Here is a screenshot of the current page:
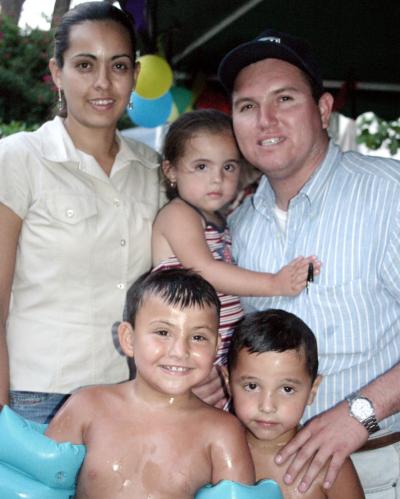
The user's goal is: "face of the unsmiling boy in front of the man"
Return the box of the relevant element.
[231,349,319,441]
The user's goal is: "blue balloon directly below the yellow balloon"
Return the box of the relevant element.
[127,91,173,128]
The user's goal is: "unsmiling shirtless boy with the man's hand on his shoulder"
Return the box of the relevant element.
[228,309,364,499]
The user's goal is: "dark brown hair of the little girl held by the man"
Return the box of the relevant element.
[163,109,239,199]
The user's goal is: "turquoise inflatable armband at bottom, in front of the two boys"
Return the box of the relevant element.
[194,480,283,499]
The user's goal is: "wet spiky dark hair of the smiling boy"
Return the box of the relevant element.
[123,269,221,328]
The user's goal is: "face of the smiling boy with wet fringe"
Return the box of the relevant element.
[125,295,218,396]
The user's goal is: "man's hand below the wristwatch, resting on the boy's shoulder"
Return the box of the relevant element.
[275,402,368,492]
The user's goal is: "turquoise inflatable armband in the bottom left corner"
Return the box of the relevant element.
[0,406,86,499]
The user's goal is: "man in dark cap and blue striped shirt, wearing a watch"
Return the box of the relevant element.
[219,30,400,499]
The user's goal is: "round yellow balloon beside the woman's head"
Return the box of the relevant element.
[135,54,173,99]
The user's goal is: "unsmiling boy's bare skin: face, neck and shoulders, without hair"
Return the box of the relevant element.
[231,349,363,499]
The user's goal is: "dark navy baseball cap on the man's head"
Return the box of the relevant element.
[218,29,323,94]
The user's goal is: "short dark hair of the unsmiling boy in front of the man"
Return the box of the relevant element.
[228,308,318,382]
